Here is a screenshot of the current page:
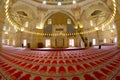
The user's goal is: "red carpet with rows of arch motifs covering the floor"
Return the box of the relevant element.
[0,46,120,80]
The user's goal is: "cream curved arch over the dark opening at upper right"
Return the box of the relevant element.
[81,1,111,20]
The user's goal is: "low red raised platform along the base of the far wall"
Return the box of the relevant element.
[31,47,85,51]
